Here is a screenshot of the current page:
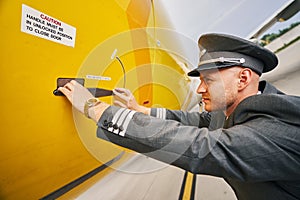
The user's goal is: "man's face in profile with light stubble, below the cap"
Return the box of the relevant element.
[197,68,238,112]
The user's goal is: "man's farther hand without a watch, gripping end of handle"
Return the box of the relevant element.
[113,88,150,115]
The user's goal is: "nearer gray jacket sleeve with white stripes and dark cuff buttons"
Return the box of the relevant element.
[97,106,300,181]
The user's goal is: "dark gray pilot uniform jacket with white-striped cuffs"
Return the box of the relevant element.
[97,82,300,200]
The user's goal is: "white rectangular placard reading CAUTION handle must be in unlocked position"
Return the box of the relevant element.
[21,4,76,47]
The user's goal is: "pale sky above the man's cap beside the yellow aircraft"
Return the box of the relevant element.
[160,0,300,40]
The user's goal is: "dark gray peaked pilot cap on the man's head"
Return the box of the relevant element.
[188,33,278,76]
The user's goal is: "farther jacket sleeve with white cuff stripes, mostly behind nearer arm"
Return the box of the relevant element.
[150,108,211,127]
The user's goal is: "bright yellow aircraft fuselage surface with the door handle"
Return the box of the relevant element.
[0,0,190,199]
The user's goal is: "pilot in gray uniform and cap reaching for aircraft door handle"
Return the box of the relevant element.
[59,33,300,200]
